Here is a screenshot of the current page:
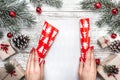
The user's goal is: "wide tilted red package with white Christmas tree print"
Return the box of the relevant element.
[37,21,59,61]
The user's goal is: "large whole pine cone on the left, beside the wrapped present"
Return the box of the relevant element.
[12,35,30,50]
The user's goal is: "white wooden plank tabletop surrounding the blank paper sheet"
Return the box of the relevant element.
[0,0,120,80]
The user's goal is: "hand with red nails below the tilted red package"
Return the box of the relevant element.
[26,48,45,80]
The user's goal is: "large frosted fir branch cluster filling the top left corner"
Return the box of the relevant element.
[0,0,35,33]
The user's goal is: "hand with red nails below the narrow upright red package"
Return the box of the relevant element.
[79,46,97,80]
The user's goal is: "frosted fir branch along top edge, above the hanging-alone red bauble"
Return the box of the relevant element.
[30,0,63,8]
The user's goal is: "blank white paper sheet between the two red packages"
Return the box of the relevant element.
[45,19,80,80]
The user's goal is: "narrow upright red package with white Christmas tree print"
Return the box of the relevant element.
[80,18,90,60]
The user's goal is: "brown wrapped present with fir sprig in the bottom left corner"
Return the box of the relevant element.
[0,59,25,80]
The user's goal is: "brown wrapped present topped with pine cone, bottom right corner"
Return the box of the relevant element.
[97,54,120,80]
